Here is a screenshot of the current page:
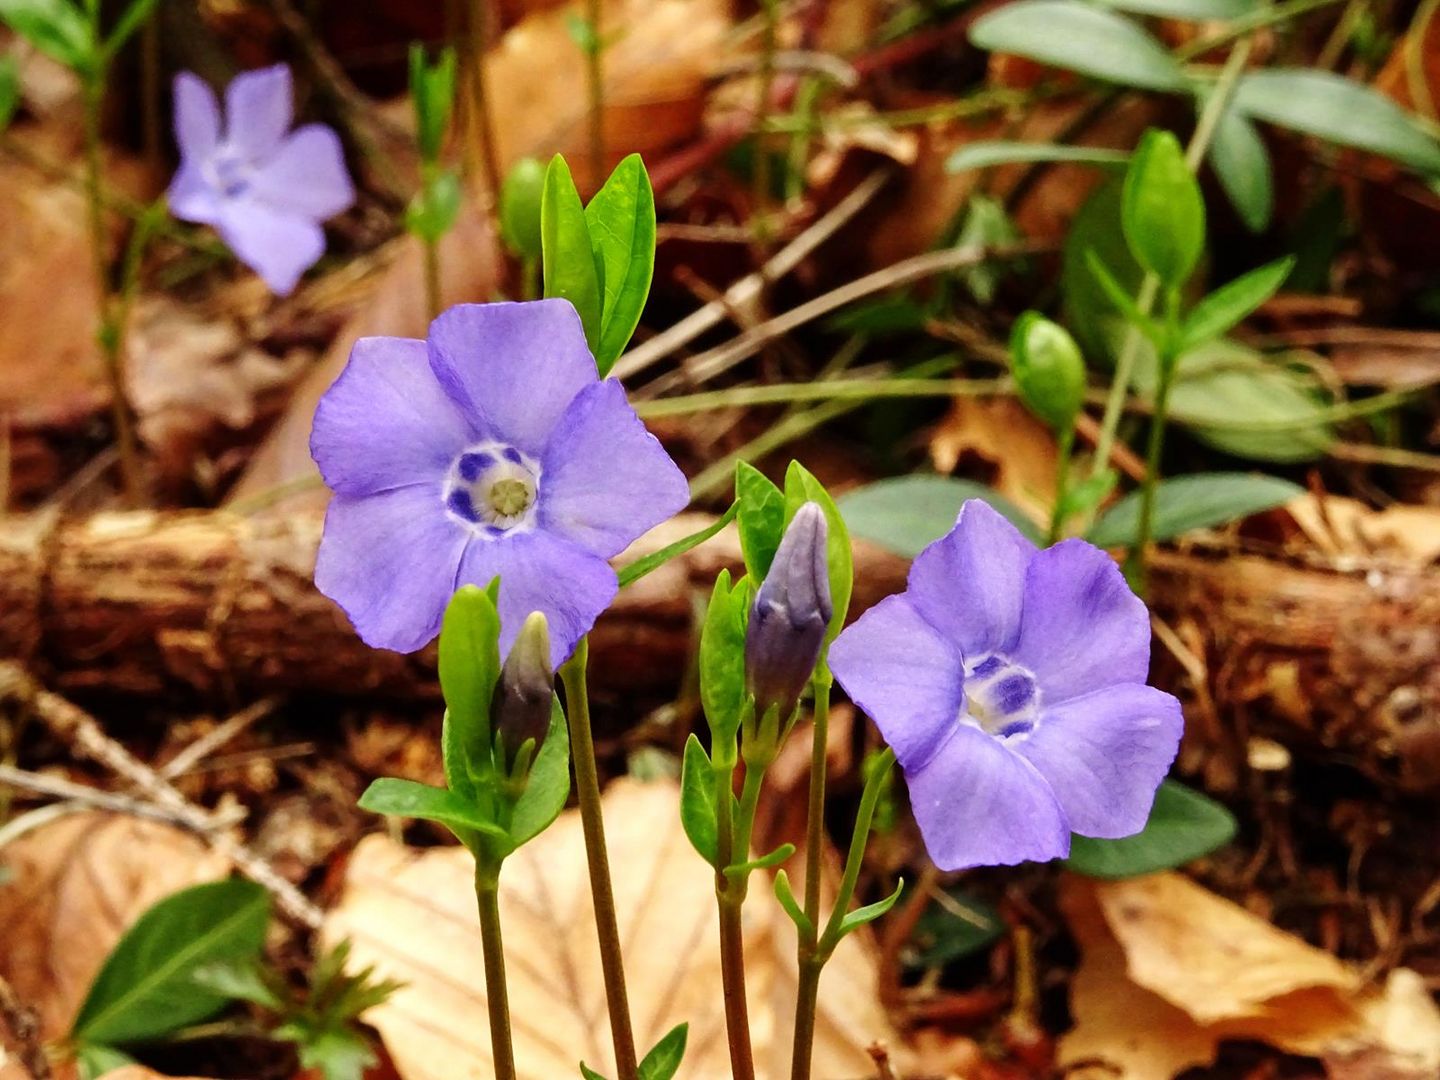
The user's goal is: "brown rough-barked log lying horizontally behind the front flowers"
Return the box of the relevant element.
[0,508,1440,791]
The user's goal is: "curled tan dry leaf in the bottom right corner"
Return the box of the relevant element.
[1060,874,1440,1080]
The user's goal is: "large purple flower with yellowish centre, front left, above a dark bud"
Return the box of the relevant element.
[310,300,690,667]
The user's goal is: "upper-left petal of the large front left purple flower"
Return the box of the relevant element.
[310,337,474,504]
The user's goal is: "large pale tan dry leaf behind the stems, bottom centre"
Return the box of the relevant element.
[323,780,894,1080]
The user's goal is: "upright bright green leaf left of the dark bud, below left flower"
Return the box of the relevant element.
[434,585,504,800]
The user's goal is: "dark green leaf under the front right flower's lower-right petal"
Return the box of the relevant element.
[1066,780,1236,878]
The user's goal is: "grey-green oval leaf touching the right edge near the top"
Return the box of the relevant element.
[1234,68,1440,176]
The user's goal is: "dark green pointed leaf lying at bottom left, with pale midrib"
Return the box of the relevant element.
[71,880,271,1044]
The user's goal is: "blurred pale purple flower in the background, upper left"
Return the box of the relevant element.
[168,63,354,297]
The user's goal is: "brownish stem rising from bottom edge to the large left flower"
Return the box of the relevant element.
[560,638,636,1080]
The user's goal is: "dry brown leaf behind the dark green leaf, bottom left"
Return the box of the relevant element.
[0,814,230,1042]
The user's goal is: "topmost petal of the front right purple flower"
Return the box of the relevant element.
[907,498,1035,657]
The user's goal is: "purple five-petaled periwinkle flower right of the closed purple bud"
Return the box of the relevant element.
[829,500,1184,870]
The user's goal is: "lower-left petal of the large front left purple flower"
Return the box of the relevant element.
[315,484,469,652]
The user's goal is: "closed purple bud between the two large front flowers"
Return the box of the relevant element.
[744,503,832,716]
